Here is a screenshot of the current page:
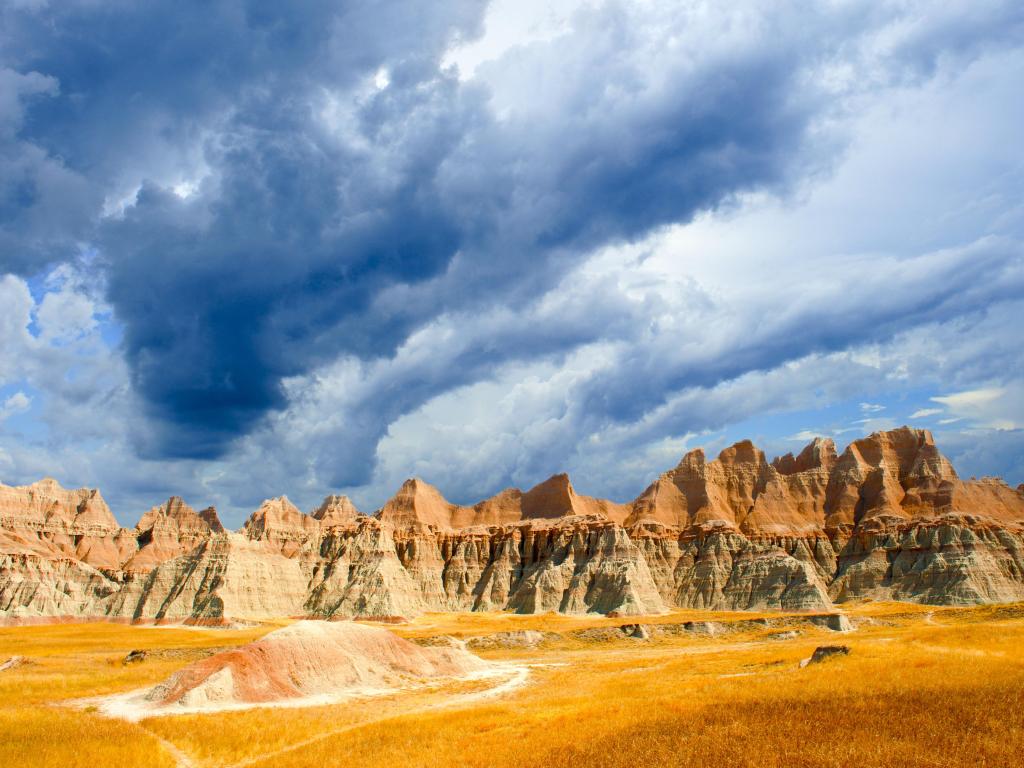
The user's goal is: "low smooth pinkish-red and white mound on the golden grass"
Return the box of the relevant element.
[98,621,497,720]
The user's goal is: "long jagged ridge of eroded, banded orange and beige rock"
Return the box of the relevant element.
[0,427,1024,626]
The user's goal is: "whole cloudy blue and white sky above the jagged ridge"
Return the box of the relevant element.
[0,0,1024,526]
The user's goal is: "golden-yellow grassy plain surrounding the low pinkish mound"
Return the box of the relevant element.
[0,603,1024,768]
